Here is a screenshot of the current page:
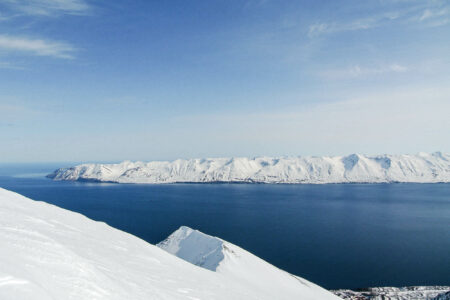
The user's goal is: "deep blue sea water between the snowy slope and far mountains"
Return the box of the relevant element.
[0,164,450,289]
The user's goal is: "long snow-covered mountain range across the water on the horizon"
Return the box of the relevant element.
[48,152,450,183]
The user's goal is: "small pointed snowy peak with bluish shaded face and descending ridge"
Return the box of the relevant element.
[157,226,342,300]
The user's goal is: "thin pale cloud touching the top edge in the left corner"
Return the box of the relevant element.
[2,0,90,16]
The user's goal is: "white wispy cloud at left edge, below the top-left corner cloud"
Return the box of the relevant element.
[0,35,76,59]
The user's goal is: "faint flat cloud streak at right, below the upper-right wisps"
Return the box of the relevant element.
[320,63,409,79]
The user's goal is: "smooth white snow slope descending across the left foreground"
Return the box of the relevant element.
[0,189,339,300]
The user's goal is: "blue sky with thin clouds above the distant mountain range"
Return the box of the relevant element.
[0,0,450,162]
